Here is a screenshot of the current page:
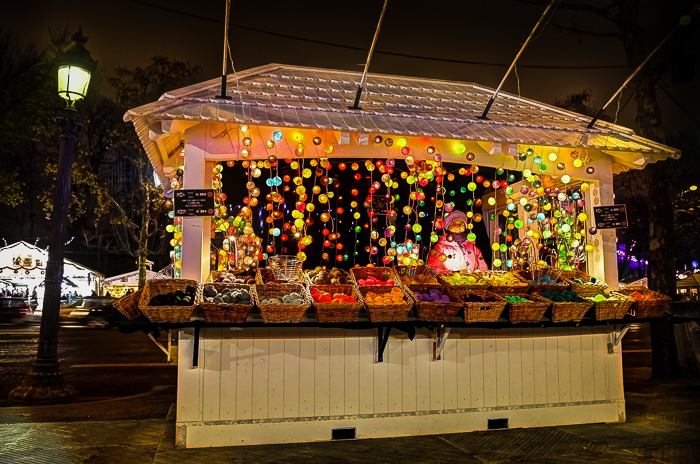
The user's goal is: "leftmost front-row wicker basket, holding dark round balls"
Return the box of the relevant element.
[139,279,202,322]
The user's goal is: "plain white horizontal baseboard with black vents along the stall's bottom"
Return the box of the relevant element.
[176,401,625,448]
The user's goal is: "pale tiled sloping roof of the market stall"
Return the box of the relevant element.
[124,64,680,180]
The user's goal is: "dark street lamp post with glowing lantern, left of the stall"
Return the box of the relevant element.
[10,29,97,404]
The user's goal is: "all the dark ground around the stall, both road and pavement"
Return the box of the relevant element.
[0,326,700,464]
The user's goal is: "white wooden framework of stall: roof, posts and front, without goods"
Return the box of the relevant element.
[125,64,680,447]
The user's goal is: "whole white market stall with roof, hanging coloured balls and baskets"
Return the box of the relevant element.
[120,65,680,447]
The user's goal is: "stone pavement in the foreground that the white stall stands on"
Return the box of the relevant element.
[0,380,700,464]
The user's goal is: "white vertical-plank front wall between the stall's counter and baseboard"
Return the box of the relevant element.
[177,326,624,450]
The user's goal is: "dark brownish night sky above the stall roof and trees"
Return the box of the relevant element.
[0,0,700,133]
